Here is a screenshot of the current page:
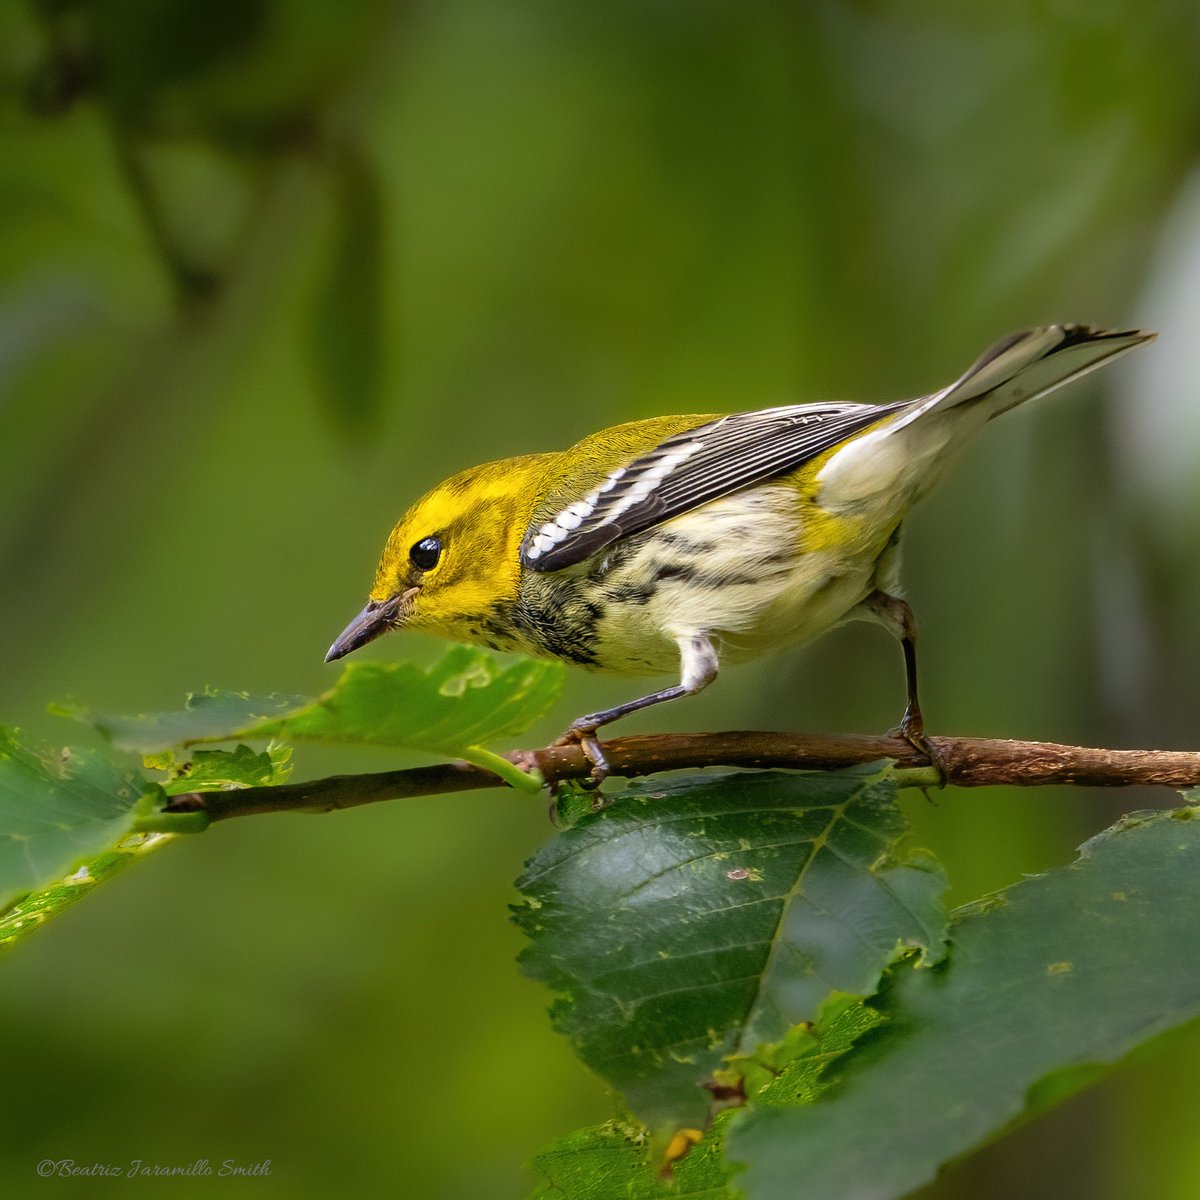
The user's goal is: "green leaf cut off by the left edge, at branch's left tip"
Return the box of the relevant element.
[0,726,157,910]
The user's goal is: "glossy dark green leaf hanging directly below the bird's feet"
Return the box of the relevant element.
[515,770,946,1129]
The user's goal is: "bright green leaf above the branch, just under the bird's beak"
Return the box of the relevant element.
[59,646,563,754]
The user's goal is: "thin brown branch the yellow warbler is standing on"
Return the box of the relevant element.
[167,732,1200,821]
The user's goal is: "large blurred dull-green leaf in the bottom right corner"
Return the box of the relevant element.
[727,809,1200,1200]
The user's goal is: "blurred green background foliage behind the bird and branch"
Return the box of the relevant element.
[0,0,1200,1200]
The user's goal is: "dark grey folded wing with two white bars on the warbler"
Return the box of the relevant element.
[521,401,911,571]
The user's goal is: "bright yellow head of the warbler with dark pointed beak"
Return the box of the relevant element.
[325,455,557,662]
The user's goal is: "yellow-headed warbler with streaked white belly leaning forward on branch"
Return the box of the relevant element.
[326,325,1154,778]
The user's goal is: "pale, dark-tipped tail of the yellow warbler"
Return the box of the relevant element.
[892,325,1156,431]
